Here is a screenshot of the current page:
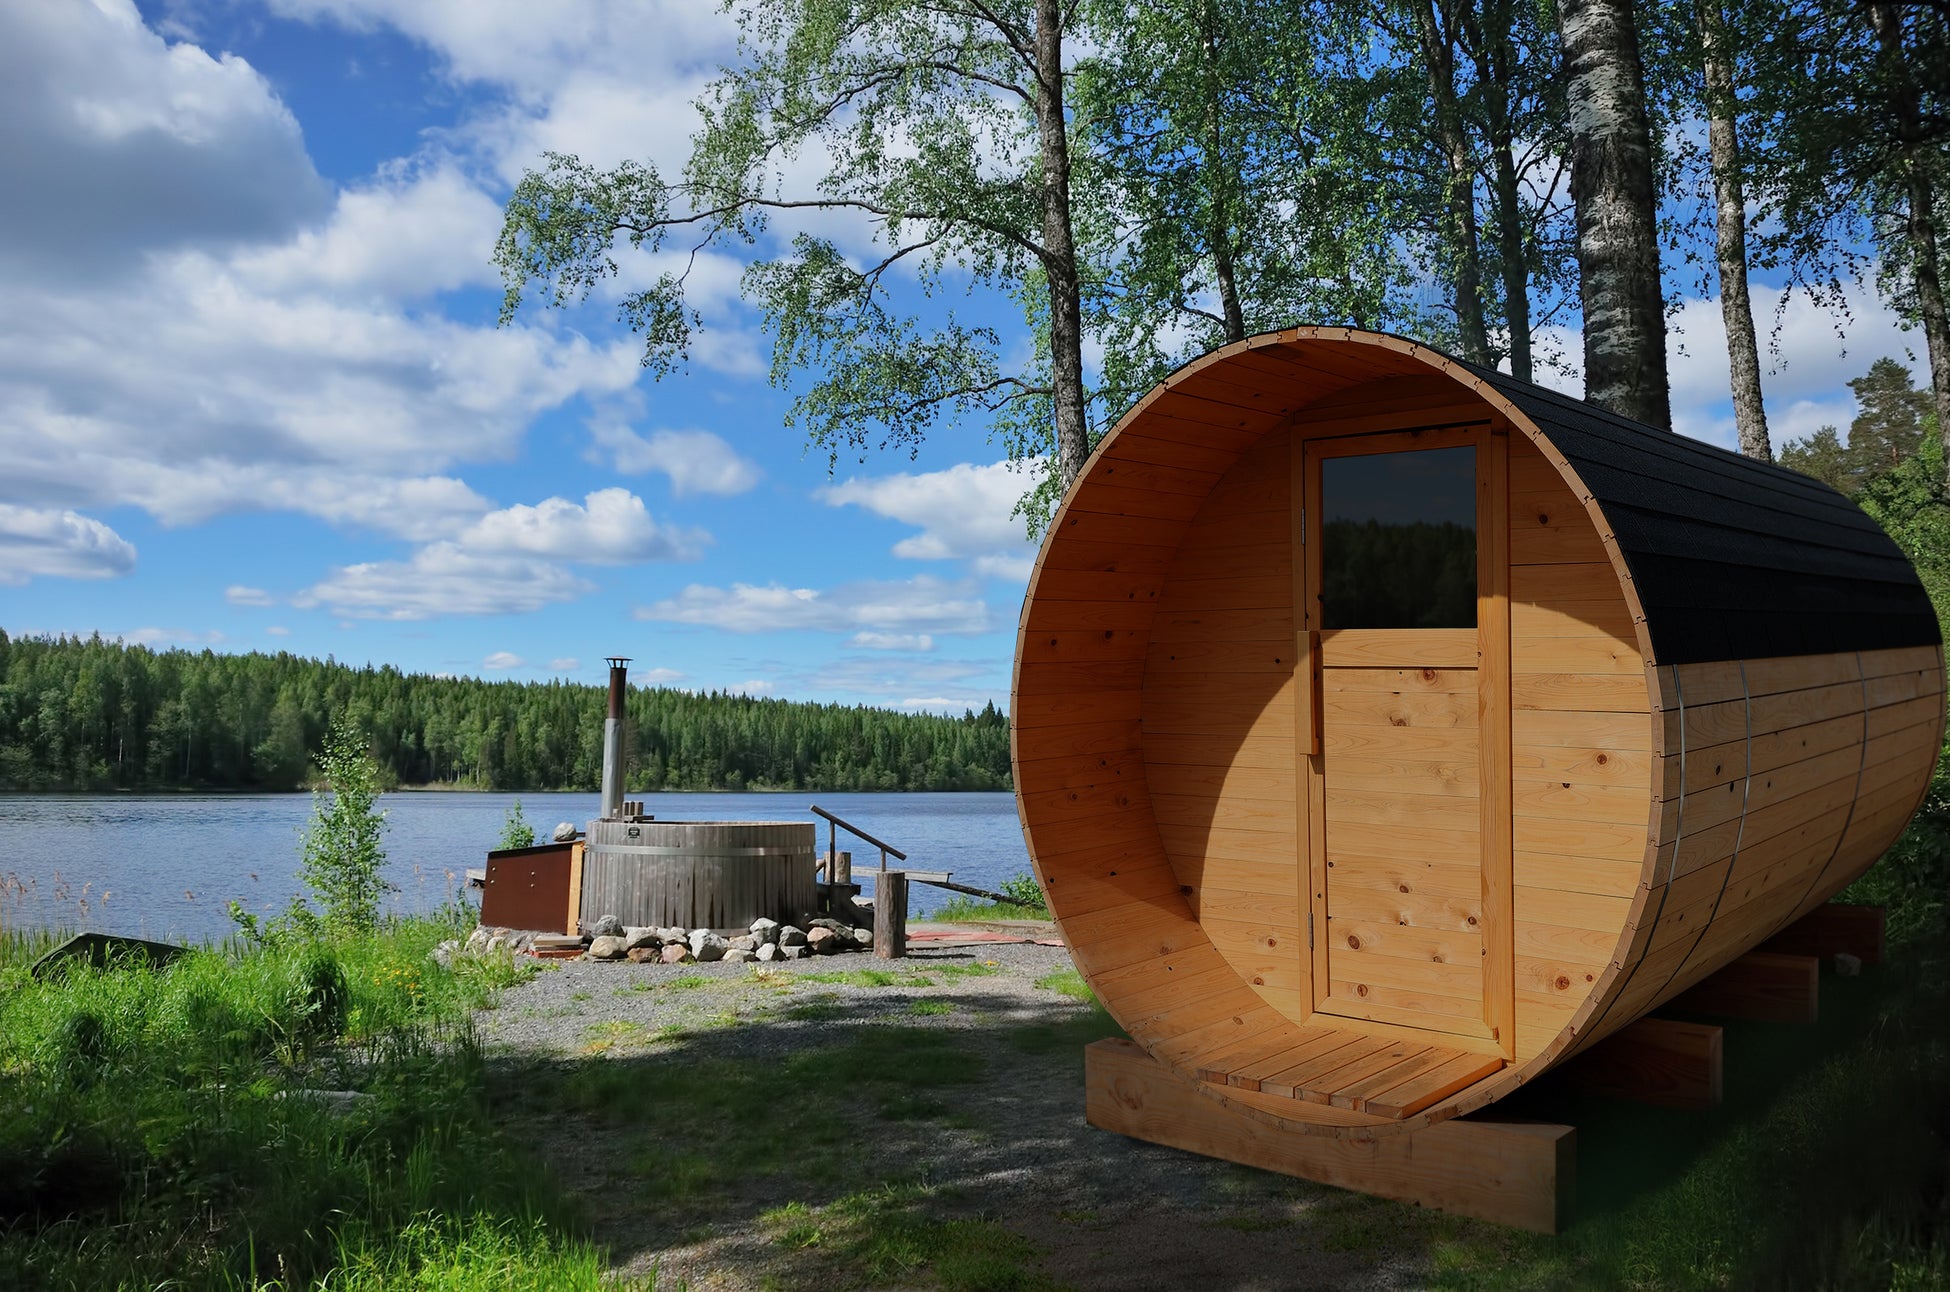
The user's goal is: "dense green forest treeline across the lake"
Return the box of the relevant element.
[0,631,1010,791]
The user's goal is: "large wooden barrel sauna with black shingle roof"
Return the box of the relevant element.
[1010,327,1944,1136]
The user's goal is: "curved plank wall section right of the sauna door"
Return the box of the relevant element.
[1509,435,1652,1064]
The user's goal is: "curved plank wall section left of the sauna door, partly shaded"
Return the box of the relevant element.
[1143,431,1312,1019]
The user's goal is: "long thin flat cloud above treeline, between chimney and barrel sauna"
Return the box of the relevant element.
[636,575,995,633]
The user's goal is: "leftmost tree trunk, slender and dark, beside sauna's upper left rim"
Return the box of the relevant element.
[1035,0,1090,489]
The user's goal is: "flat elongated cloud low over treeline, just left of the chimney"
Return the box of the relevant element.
[293,542,593,620]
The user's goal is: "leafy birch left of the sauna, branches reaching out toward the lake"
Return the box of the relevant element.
[495,0,1090,503]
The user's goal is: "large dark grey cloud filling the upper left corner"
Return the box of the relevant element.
[0,0,330,281]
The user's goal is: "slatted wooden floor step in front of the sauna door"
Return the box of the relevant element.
[1197,1025,1503,1119]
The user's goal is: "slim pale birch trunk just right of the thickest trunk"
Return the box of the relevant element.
[1697,0,1775,462]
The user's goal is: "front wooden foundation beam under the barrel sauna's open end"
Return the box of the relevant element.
[1084,1039,1578,1234]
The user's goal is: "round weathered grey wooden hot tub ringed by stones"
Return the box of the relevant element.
[581,818,819,933]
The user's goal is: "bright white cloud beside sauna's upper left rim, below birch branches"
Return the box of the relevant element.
[819,460,1039,581]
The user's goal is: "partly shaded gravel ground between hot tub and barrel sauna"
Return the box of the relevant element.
[468,943,1461,1292]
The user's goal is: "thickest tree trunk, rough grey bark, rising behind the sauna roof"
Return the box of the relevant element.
[1558,0,1673,431]
